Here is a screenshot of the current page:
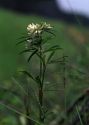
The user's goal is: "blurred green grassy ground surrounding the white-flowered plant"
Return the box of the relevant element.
[0,10,89,125]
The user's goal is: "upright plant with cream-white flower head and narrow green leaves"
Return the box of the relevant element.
[18,23,60,125]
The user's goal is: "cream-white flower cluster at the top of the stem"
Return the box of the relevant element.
[27,22,52,35]
